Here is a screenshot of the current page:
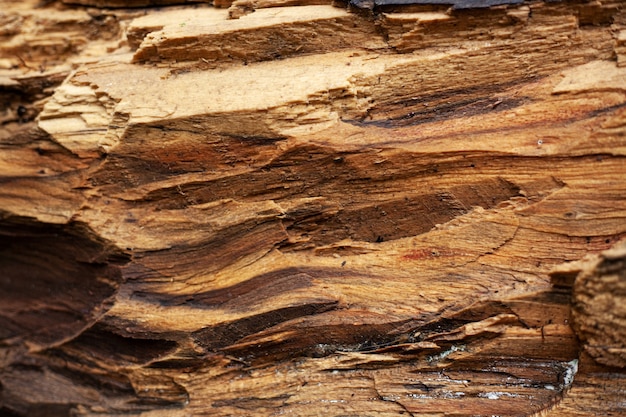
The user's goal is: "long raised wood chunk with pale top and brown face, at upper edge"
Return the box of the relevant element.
[133,5,385,67]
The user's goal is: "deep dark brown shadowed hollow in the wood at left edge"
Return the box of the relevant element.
[0,213,129,346]
